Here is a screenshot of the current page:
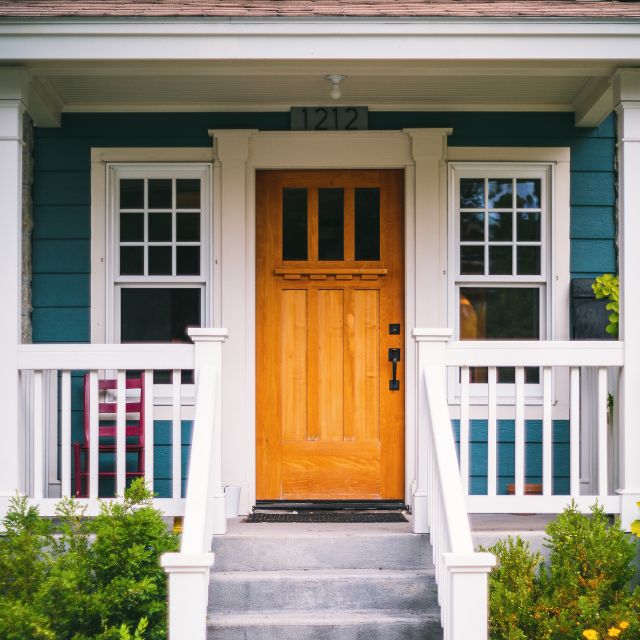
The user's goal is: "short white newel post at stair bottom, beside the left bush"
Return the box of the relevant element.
[160,553,213,640]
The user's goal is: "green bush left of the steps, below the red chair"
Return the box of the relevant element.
[0,479,177,640]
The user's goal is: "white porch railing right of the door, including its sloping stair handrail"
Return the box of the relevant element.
[414,329,624,640]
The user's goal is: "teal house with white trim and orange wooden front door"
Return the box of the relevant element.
[0,0,640,639]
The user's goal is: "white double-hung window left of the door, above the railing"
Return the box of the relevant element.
[107,164,211,342]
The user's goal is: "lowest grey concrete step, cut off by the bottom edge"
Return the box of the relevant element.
[207,610,442,640]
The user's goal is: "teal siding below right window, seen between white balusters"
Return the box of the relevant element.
[451,420,570,495]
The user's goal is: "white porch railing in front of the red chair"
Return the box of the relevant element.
[15,330,228,515]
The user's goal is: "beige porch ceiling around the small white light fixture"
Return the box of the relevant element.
[27,60,616,116]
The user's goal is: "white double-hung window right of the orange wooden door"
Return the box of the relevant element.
[451,163,551,384]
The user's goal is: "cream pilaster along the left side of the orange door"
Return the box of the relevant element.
[209,129,255,513]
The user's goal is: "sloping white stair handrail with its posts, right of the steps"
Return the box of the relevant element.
[414,332,495,640]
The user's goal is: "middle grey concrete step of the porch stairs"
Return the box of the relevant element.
[209,569,438,614]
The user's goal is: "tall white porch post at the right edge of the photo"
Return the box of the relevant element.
[613,69,640,530]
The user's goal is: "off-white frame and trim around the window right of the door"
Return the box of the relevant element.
[447,156,570,404]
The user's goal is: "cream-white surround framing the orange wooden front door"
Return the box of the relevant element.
[209,128,452,513]
